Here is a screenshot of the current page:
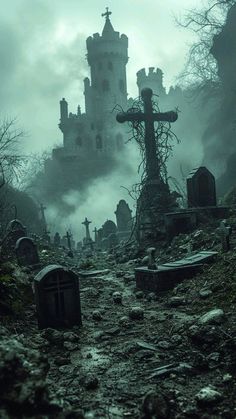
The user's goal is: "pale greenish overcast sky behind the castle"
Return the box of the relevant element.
[0,0,204,151]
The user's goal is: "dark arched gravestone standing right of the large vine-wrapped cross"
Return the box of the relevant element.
[187,166,216,208]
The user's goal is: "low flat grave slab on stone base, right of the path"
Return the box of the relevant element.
[135,251,217,292]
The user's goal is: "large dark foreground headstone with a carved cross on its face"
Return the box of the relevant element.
[34,265,82,329]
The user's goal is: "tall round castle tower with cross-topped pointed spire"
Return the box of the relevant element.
[84,8,128,119]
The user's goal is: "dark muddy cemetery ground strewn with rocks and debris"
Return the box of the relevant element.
[0,219,236,419]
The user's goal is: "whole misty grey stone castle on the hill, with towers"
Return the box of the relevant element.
[42,8,182,197]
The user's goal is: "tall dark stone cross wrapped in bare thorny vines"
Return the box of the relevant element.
[116,88,178,180]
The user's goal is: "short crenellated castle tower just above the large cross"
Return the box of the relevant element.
[137,67,166,97]
